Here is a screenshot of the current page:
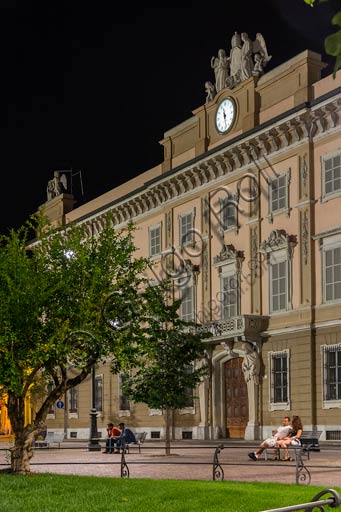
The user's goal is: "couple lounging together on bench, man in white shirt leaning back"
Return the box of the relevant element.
[249,416,303,461]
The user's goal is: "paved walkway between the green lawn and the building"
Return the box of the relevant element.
[0,440,341,488]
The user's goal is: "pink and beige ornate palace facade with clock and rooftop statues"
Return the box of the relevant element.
[41,39,341,440]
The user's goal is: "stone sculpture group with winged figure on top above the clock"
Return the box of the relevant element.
[205,32,272,103]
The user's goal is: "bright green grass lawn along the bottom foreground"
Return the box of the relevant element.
[0,474,334,512]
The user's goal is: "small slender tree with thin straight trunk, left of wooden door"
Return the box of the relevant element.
[121,283,209,454]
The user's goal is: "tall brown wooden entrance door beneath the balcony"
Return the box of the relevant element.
[225,357,249,439]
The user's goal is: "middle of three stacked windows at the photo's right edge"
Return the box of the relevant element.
[324,247,341,302]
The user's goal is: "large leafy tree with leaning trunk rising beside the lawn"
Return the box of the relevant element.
[0,214,150,474]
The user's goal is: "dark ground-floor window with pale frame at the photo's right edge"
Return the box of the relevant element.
[322,345,341,408]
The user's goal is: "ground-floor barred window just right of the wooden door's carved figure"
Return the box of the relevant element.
[269,350,290,410]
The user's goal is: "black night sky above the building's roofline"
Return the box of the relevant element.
[0,0,341,233]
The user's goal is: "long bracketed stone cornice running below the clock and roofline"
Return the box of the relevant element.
[73,90,341,229]
